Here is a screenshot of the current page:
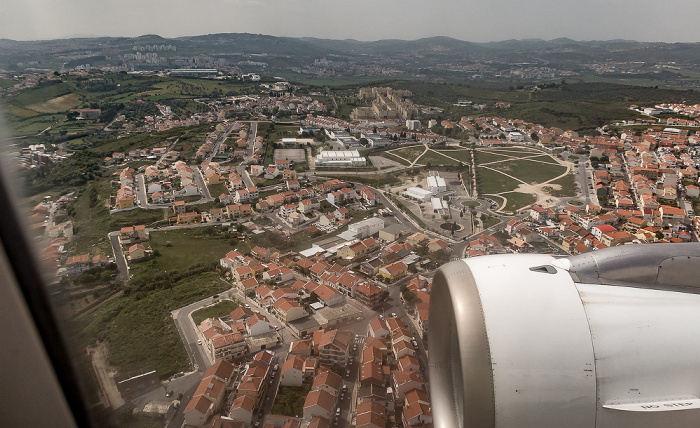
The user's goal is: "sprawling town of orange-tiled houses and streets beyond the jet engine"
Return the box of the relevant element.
[13,68,700,428]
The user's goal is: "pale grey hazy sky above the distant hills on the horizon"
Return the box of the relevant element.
[0,0,700,42]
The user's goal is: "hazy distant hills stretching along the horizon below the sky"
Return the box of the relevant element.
[0,33,700,87]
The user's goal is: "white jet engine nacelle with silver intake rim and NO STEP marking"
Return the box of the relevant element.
[428,243,700,428]
